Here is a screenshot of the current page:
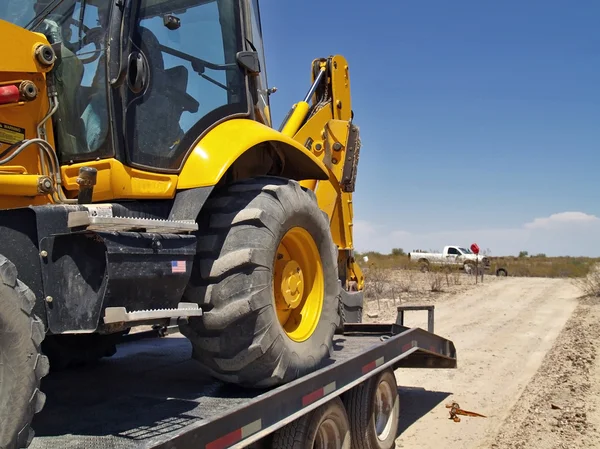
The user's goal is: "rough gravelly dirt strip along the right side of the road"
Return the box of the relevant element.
[492,298,600,449]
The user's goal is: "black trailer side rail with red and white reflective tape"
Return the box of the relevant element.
[152,324,456,449]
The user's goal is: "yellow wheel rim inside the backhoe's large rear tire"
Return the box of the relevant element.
[273,228,325,342]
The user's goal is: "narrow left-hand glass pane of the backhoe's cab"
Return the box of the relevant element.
[34,0,114,163]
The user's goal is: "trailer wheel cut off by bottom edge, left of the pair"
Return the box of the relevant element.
[272,397,352,449]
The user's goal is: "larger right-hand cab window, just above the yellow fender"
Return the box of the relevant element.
[126,0,248,170]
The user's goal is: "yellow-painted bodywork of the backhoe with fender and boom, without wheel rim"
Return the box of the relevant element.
[0,16,364,290]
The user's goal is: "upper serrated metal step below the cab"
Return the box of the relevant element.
[67,211,198,234]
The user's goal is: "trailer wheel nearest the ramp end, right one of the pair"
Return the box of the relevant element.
[344,369,400,449]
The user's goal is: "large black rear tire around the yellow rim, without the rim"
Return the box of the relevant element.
[180,177,340,388]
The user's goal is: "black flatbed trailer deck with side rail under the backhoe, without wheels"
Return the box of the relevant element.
[30,316,456,449]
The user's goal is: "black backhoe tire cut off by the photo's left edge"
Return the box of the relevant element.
[0,256,49,449]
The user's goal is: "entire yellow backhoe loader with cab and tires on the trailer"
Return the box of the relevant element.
[0,0,364,449]
